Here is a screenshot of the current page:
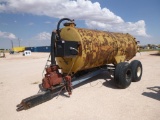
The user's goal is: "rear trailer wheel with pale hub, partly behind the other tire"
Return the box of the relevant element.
[130,60,143,82]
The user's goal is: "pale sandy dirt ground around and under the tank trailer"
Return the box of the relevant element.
[0,52,160,120]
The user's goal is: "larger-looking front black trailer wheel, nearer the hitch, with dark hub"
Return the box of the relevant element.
[114,62,132,89]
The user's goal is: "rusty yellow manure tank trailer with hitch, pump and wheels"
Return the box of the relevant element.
[17,18,142,111]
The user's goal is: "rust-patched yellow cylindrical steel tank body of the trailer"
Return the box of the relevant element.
[56,24,137,74]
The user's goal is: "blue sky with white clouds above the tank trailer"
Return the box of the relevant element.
[0,0,160,49]
